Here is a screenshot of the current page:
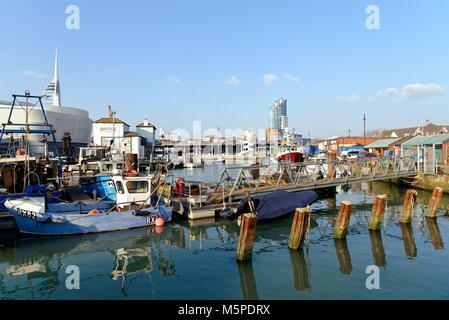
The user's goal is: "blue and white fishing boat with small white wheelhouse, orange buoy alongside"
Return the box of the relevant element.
[5,176,173,235]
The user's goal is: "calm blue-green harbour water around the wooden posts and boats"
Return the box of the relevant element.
[0,166,449,300]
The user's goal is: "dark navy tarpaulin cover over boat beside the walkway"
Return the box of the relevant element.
[238,190,318,221]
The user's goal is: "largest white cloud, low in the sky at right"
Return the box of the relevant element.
[376,83,444,101]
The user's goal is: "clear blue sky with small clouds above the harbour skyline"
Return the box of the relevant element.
[0,0,449,137]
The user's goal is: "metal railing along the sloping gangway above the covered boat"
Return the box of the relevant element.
[215,157,418,201]
